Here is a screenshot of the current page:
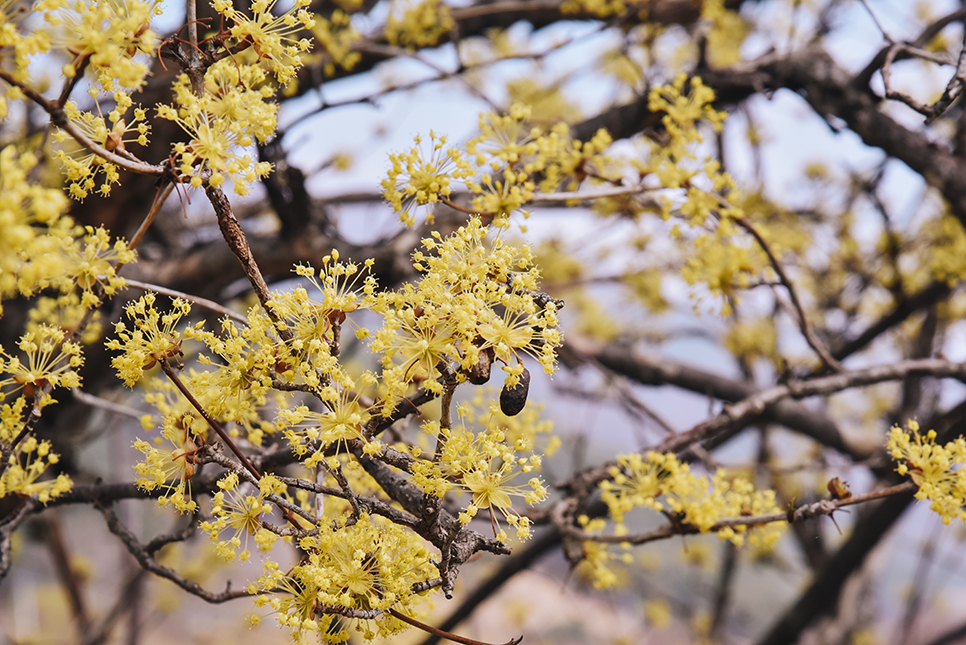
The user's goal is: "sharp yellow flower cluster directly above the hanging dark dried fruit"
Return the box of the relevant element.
[372,218,562,400]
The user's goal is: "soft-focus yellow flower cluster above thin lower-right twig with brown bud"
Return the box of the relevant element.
[600,452,783,546]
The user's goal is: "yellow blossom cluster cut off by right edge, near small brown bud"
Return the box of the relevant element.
[887,421,966,524]
